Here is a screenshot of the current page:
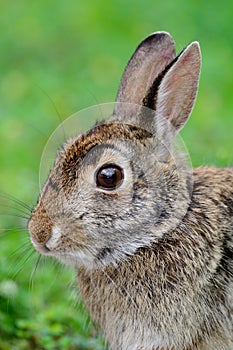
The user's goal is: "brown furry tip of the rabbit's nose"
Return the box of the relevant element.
[28,205,53,249]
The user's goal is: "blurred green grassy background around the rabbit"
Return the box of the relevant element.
[0,0,233,349]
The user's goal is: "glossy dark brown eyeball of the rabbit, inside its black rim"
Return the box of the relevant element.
[97,167,123,189]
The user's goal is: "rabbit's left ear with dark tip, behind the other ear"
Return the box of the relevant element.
[112,32,176,120]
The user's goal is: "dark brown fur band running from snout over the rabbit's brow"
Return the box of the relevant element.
[40,123,152,200]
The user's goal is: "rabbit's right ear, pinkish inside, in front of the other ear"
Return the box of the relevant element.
[155,42,201,132]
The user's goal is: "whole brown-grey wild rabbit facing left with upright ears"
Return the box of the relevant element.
[28,32,233,350]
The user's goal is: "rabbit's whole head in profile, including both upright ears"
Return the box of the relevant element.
[29,32,201,269]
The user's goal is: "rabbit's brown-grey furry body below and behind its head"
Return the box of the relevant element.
[77,168,233,350]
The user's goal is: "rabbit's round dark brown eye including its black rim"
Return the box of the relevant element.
[96,164,124,190]
